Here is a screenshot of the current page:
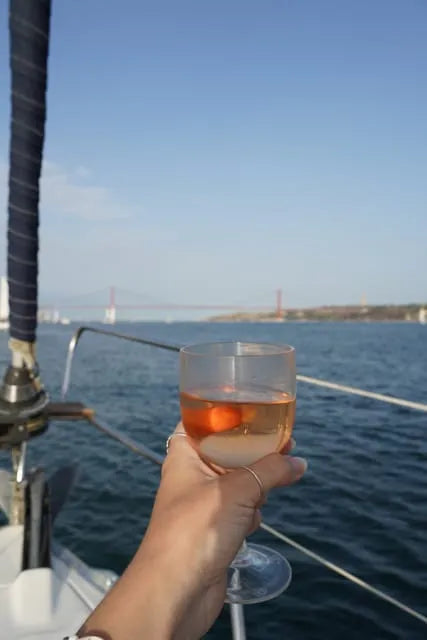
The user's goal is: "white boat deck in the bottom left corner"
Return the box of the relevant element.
[0,470,116,640]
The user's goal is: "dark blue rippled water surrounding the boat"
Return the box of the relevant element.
[0,323,427,640]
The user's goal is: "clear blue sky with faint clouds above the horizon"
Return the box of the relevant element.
[0,0,427,318]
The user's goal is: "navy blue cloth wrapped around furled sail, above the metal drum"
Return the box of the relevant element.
[7,0,51,342]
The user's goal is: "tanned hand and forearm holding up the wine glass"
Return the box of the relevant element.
[79,424,306,640]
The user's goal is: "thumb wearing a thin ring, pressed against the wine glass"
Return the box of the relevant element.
[223,453,307,506]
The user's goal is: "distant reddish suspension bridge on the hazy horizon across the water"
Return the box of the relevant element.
[39,286,284,324]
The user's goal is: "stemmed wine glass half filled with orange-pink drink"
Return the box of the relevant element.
[180,342,296,604]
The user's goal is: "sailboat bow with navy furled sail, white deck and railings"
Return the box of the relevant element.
[0,0,427,640]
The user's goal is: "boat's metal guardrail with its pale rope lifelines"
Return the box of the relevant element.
[62,326,427,640]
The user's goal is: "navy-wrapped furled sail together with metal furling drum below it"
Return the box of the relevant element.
[0,0,51,524]
